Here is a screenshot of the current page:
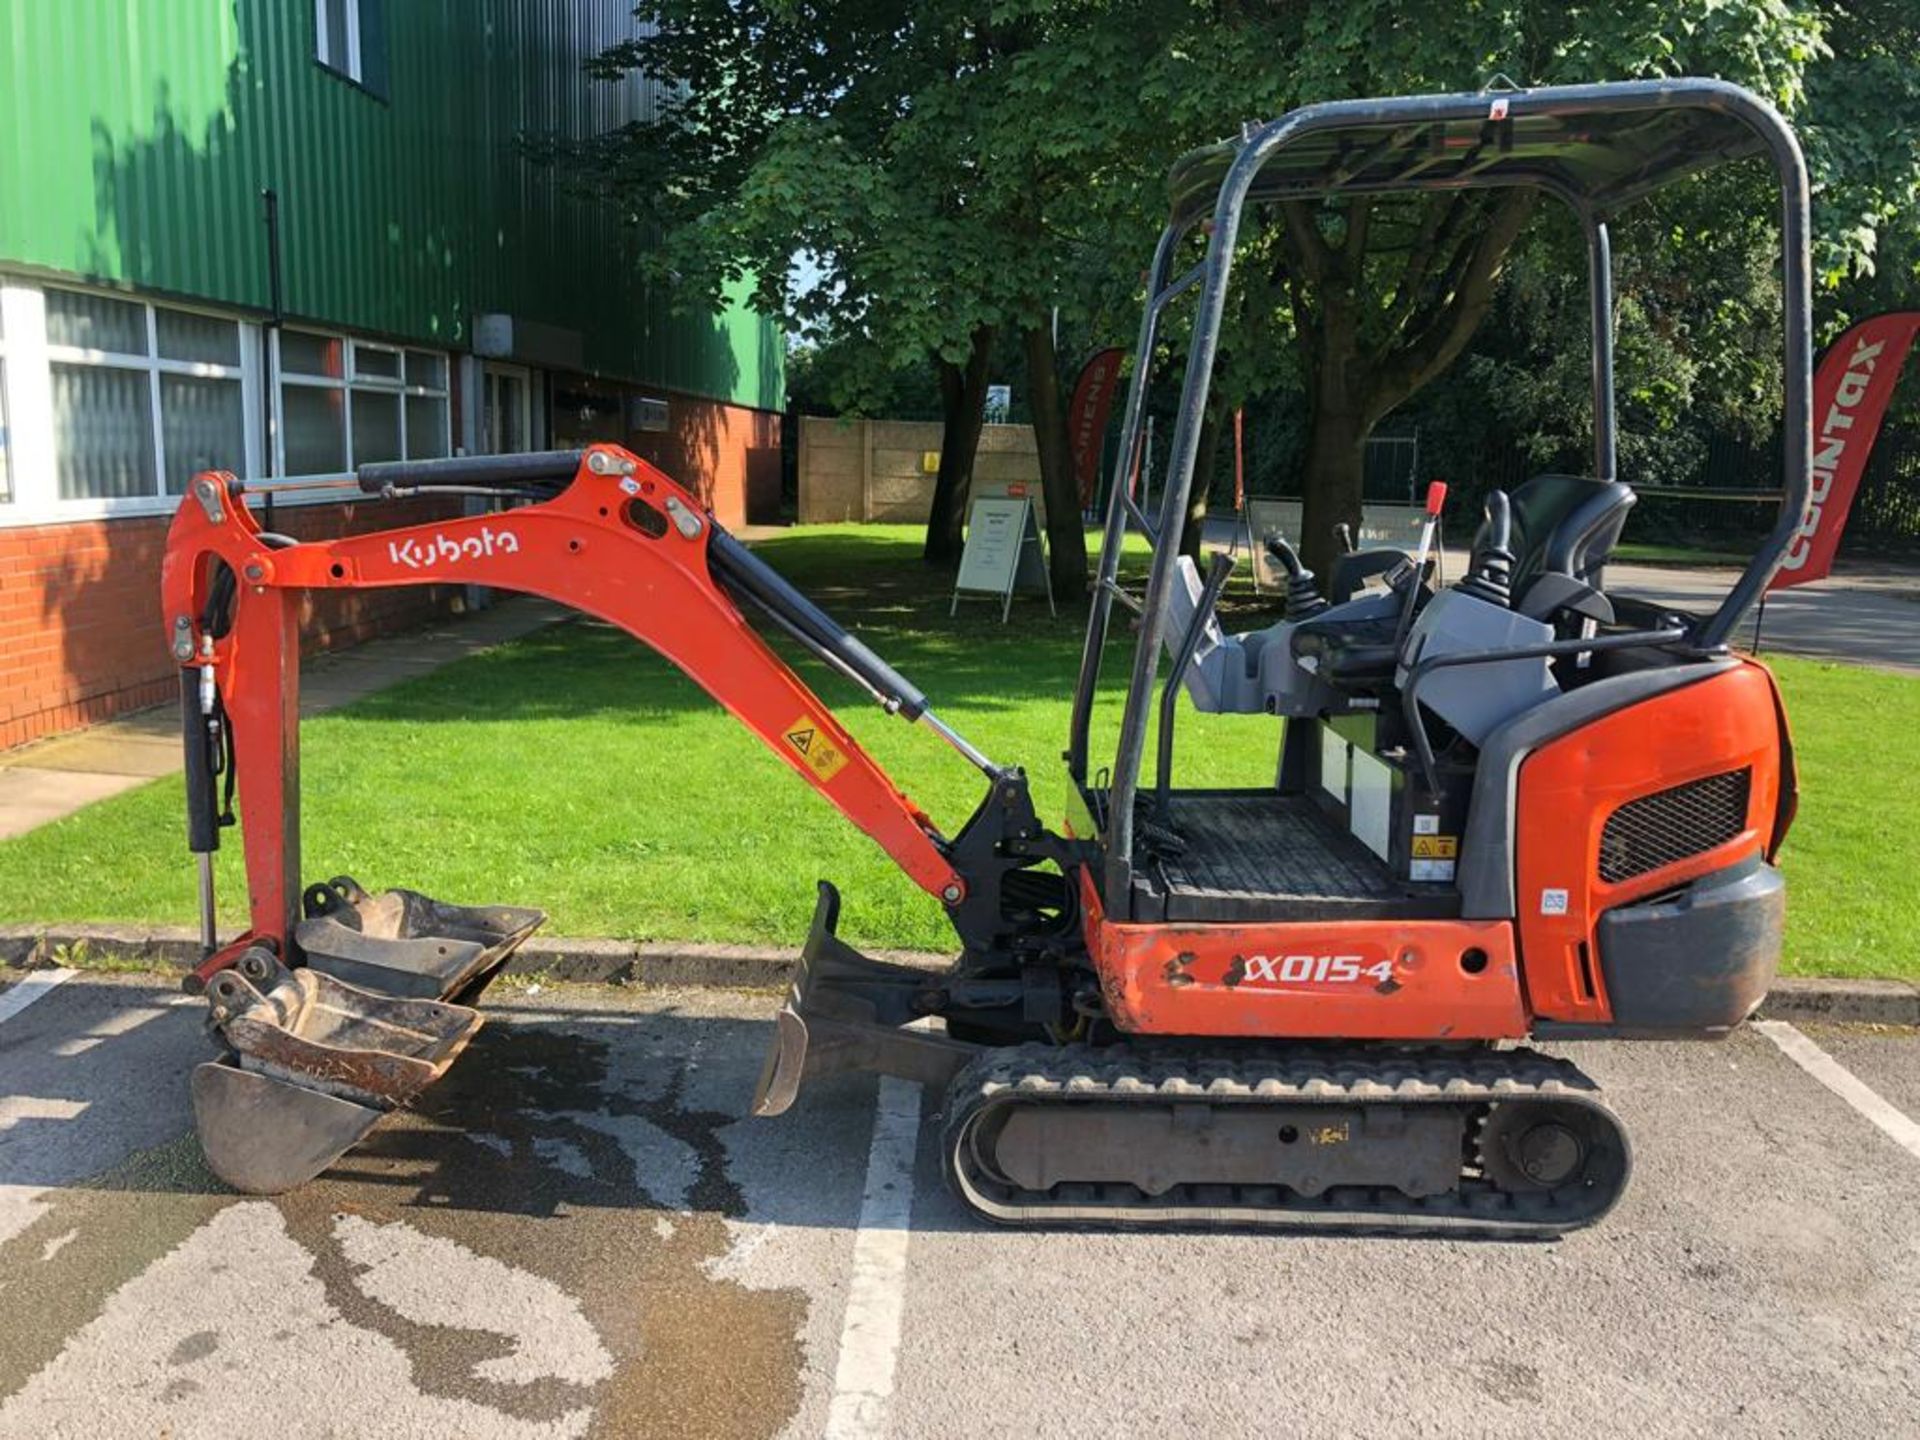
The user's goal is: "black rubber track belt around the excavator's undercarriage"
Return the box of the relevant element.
[943,1044,1632,1238]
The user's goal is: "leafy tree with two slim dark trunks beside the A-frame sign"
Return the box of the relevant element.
[570,0,1181,597]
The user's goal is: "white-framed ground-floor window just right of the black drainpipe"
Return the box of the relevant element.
[278,330,453,474]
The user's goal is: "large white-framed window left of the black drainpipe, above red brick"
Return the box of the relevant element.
[46,290,246,499]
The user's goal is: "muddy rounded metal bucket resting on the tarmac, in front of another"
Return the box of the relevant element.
[194,948,480,1194]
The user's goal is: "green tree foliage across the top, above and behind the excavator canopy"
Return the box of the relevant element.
[572,0,1920,526]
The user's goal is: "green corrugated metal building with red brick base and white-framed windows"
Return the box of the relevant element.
[0,0,783,745]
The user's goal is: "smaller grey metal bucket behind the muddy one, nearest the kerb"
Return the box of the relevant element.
[294,876,547,1000]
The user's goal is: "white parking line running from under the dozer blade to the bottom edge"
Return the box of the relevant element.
[822,1075,920,1440]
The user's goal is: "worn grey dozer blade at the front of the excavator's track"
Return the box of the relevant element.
[753,879,979,1116]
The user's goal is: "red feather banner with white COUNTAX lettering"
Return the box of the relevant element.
[1766,311,1920,589]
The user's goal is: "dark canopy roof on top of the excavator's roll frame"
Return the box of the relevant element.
[1169,81,1793,223]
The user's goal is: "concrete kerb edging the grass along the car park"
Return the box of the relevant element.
[0,925,1920,1025]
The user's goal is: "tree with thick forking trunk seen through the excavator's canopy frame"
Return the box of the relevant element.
[1121,0,1822,568]
